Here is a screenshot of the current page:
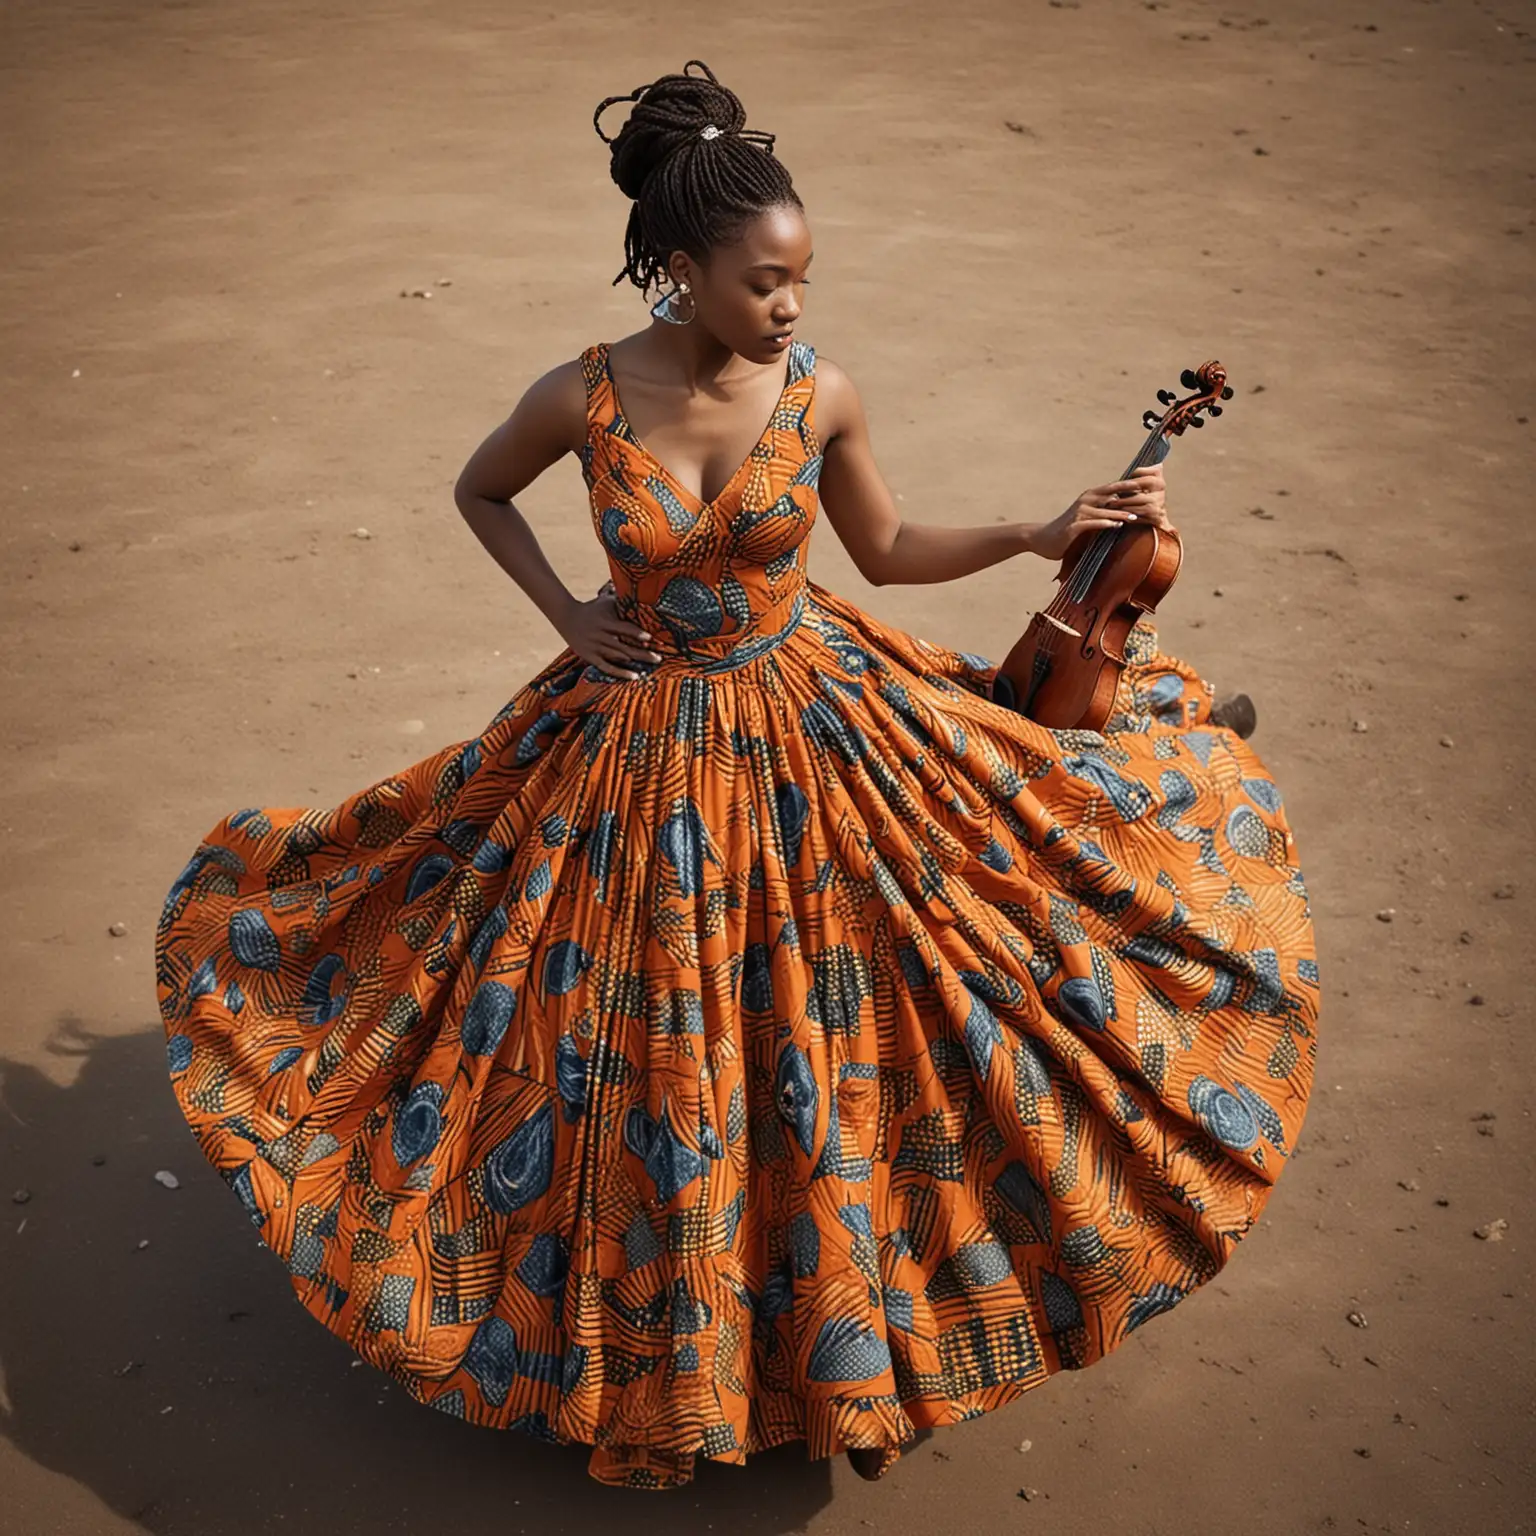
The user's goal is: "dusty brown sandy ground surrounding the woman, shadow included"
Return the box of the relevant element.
[0,0,1536,1536]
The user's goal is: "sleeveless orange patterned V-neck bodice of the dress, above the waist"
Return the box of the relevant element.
[582,341,822,671]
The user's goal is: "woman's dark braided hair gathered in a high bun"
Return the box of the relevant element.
[591,58,803,293]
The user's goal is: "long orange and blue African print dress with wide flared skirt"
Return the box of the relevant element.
[155,341,1319,1487]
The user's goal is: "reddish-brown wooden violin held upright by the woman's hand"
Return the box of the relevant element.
[992,362,1232,731]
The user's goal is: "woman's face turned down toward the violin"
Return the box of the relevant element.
[668,204,811,362]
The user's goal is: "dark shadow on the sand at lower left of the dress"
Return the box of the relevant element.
[0,1020,841,1536]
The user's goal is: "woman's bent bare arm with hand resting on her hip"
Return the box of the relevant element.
[453,359,654,677]
